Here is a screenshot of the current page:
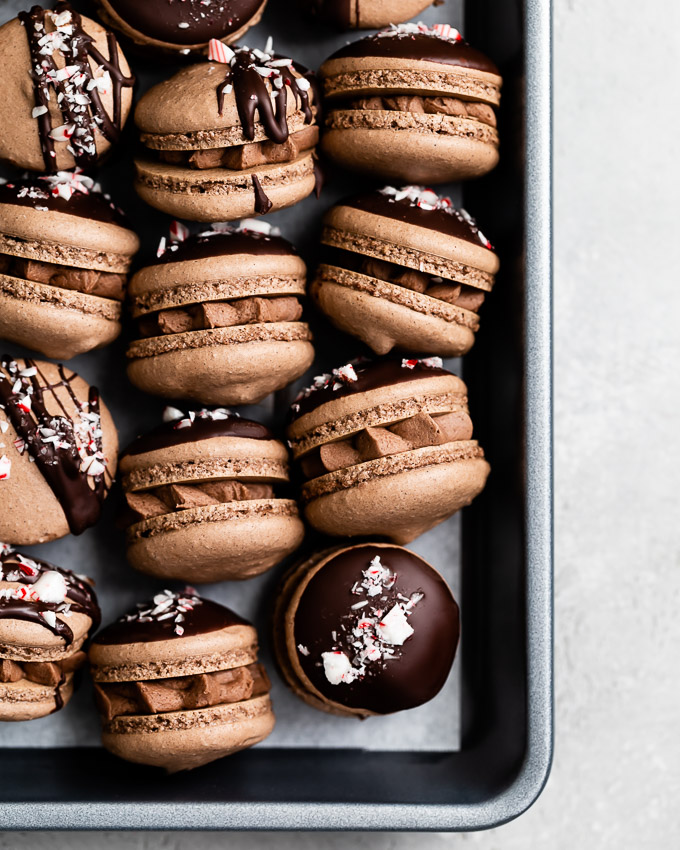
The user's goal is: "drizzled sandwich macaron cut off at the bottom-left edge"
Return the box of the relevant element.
[0,543,99,720]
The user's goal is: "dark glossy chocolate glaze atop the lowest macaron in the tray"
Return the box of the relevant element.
[94,597,250,646]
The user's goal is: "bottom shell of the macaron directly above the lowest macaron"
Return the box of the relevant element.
[127,499,304,584]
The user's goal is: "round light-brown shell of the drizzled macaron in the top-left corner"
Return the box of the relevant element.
[0,6,134,172]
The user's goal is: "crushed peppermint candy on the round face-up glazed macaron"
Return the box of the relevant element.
[314,556,424,685]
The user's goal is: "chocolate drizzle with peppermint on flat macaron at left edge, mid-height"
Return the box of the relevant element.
[0,355,108,534]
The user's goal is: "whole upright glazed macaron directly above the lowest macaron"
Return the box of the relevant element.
[120,408,304,583]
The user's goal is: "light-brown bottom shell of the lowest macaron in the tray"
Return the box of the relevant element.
[102,694,275,773]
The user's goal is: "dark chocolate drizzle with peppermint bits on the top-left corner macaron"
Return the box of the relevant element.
[18,2,135,172]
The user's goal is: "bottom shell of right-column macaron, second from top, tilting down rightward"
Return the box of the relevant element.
[311,274,478,357]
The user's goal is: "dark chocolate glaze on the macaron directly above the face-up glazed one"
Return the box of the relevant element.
[289,358,452,422]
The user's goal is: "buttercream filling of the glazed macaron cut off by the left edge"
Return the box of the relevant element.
[0,254,127,301]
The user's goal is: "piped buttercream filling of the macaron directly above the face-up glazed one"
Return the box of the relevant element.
[300,410,472,479]
